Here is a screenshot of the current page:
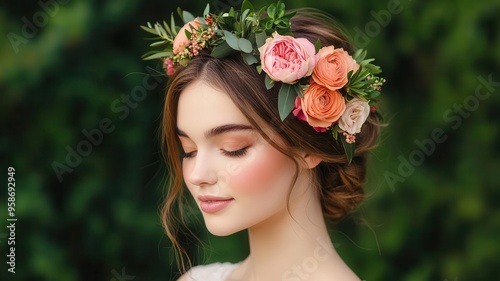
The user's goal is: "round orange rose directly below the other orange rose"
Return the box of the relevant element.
[301,82,345,128]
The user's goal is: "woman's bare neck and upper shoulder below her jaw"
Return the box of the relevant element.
[230,178,359,281]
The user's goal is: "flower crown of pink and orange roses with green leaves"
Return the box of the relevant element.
[141,0,385,162]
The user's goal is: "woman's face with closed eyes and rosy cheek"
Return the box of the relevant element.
[177,81,304,236]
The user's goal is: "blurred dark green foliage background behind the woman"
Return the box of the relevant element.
[0,0,500,281]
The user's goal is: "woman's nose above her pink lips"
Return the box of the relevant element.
[185,152,217,187]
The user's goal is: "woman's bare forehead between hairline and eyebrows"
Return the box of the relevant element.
[177,81,250,136]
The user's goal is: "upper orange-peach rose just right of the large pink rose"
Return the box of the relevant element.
[312,46,359,91]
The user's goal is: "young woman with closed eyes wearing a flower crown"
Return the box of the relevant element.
[143,1,383,281]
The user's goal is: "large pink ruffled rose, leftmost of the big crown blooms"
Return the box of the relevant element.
[259,32,316,84]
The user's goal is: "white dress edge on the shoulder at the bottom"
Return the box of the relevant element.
[187,262,238,281]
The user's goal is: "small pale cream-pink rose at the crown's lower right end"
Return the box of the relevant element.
[339,98,370,135]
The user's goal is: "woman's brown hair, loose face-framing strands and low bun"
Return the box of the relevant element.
[161,9,378,271]
